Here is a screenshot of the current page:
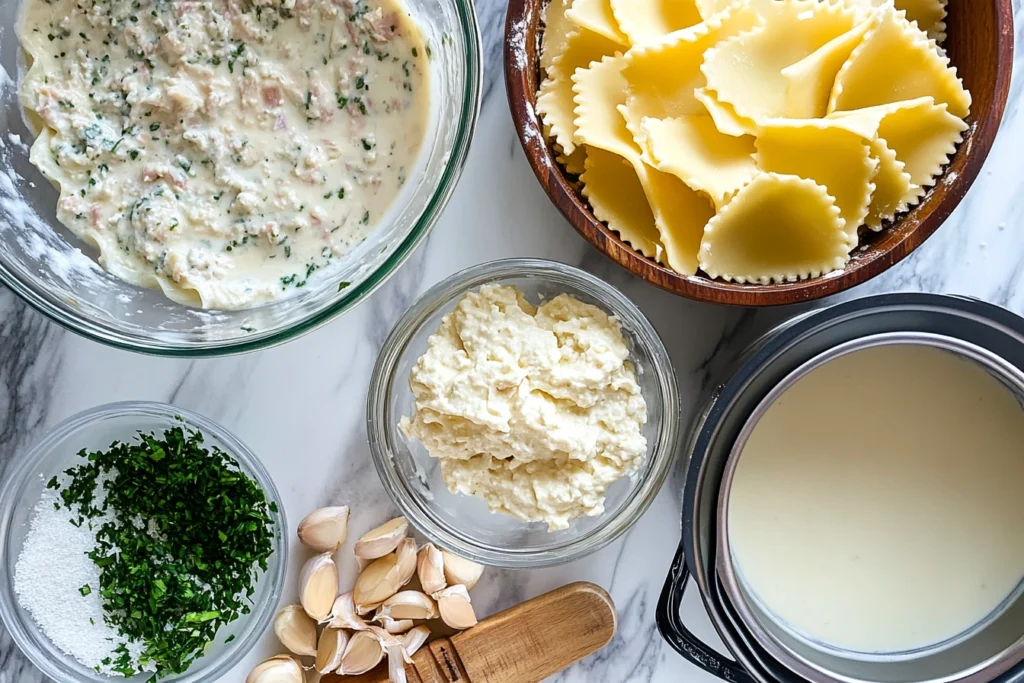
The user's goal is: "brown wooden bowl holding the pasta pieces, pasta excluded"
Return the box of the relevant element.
[505,0,1014,306]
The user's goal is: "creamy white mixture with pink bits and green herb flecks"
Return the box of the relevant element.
[18,0,429,308]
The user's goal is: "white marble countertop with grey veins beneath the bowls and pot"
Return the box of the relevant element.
[0,0,1024,683]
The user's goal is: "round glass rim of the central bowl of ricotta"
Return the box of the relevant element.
[367,258,681,568]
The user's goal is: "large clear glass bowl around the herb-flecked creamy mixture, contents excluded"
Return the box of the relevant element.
[0,0,482,356]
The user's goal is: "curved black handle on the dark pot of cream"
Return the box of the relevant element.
[654,544,755,683]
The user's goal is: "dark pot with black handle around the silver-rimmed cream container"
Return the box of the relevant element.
[655,294,1024,683]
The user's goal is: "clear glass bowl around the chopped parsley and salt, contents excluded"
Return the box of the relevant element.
[0,401,288,683]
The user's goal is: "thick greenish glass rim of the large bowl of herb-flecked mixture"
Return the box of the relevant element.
[0,0,483,358]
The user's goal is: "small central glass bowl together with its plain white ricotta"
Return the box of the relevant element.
[367,259,681,567]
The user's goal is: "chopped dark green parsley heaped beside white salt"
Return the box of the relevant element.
[47,426,278,681]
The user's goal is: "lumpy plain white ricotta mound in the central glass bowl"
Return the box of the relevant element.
[400,285,647,531]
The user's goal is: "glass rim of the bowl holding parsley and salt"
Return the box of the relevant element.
[0,400,290,683]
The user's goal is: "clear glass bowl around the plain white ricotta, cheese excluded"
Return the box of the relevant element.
[367,259,680,567]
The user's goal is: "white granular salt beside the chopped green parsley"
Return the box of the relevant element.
[14,488,140,676]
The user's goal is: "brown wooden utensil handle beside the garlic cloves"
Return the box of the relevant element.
[322,582,615,683]
